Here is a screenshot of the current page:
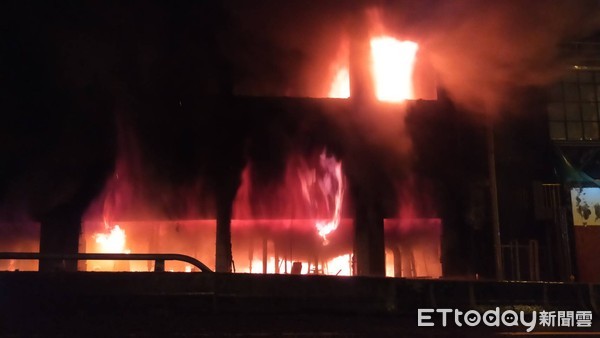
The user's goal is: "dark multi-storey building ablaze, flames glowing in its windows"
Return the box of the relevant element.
[0,1,600,278]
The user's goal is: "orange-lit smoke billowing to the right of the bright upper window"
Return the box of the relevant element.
[418,0,600,113]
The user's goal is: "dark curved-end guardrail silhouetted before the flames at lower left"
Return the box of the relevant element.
[0,252,213,272]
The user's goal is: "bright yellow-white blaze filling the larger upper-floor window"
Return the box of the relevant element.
[371,36,419,102]
